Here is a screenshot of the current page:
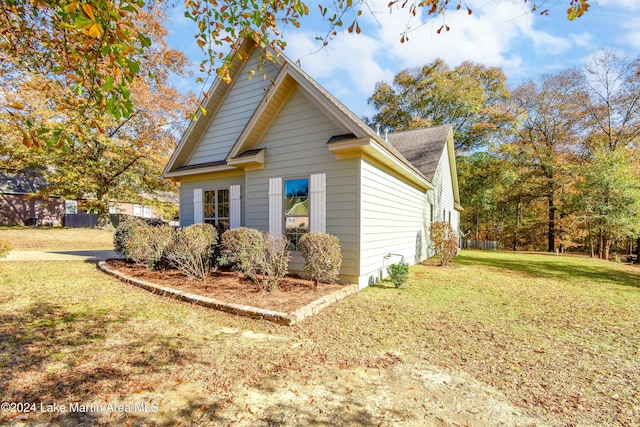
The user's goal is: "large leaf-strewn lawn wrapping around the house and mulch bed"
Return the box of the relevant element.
[0,252,640,426]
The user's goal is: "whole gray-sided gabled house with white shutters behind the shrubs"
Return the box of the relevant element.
[165,41,462,287]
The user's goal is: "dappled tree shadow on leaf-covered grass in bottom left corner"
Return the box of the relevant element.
[0,302,198,425]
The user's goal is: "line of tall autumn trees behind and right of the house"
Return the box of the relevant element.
[369,52,640,259]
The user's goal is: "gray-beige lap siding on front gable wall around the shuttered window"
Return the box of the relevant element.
[247,90,359,278]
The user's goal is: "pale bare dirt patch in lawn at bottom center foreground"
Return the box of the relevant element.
[126,356,547,427]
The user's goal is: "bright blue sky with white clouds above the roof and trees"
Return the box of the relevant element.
[286,0,640,114]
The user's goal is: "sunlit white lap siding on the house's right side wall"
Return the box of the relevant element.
[359,160,429,286]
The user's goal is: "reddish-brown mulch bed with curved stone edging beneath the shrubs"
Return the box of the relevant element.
[107,260,344,313]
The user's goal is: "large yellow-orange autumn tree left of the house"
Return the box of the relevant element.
[0,5,190,226]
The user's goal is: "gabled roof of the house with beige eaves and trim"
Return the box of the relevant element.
[165,39,458,202]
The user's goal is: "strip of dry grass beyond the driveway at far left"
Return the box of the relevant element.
[0,227,113,251]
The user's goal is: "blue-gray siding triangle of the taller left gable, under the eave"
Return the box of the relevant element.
[187,52,279,165]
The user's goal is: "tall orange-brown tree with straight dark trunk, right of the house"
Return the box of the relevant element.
[501,70,586,252]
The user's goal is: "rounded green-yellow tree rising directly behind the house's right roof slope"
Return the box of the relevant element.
[369,59,512,150]
